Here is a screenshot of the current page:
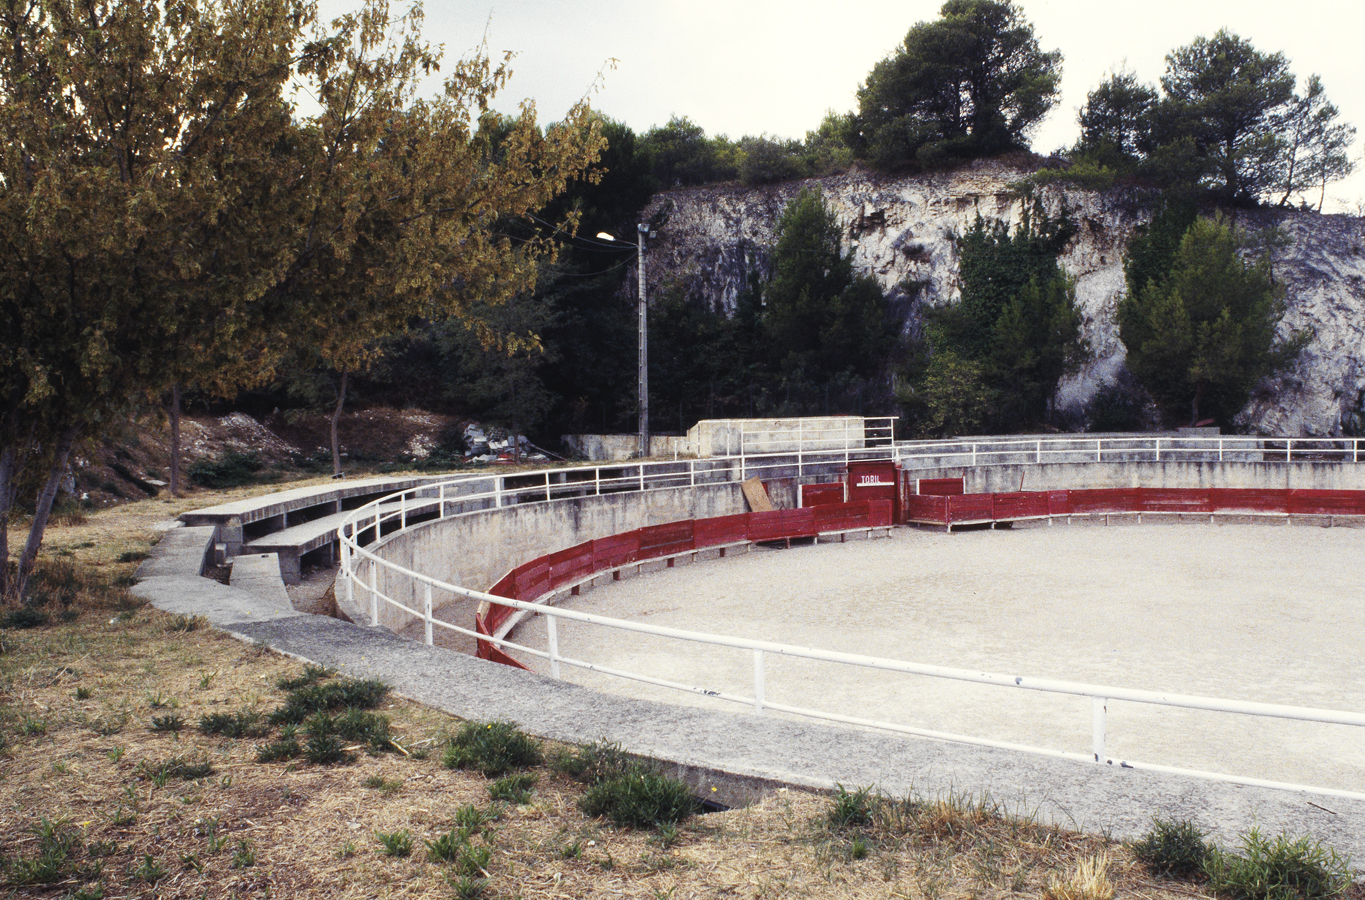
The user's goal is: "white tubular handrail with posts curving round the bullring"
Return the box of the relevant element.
[339,437,1365,799]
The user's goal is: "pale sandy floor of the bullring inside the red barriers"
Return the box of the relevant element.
[515,524,1365,792]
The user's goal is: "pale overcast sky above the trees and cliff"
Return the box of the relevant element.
[398,0,1365,210]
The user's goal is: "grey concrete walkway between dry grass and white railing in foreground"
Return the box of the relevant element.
[134,527,1365,864]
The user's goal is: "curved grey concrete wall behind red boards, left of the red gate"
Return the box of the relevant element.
[355,483,748,631]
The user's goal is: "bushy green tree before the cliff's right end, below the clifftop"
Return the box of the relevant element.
[1118,217,1309,425]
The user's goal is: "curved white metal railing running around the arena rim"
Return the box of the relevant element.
[330,436,1365,799]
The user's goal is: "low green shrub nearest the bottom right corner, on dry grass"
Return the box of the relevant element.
[1204,828,1351,900]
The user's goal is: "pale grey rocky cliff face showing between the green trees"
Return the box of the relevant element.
[647,160,1365,436]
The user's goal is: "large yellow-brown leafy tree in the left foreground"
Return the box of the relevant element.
[0,0,598,587]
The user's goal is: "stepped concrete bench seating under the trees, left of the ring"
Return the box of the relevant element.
[180,477,438,585]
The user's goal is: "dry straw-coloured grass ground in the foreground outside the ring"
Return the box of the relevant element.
[0,496,1354,900]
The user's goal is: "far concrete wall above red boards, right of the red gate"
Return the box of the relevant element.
[906,460,1365,494]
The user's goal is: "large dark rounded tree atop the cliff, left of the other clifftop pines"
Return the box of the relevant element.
[854,0,1062,169]
